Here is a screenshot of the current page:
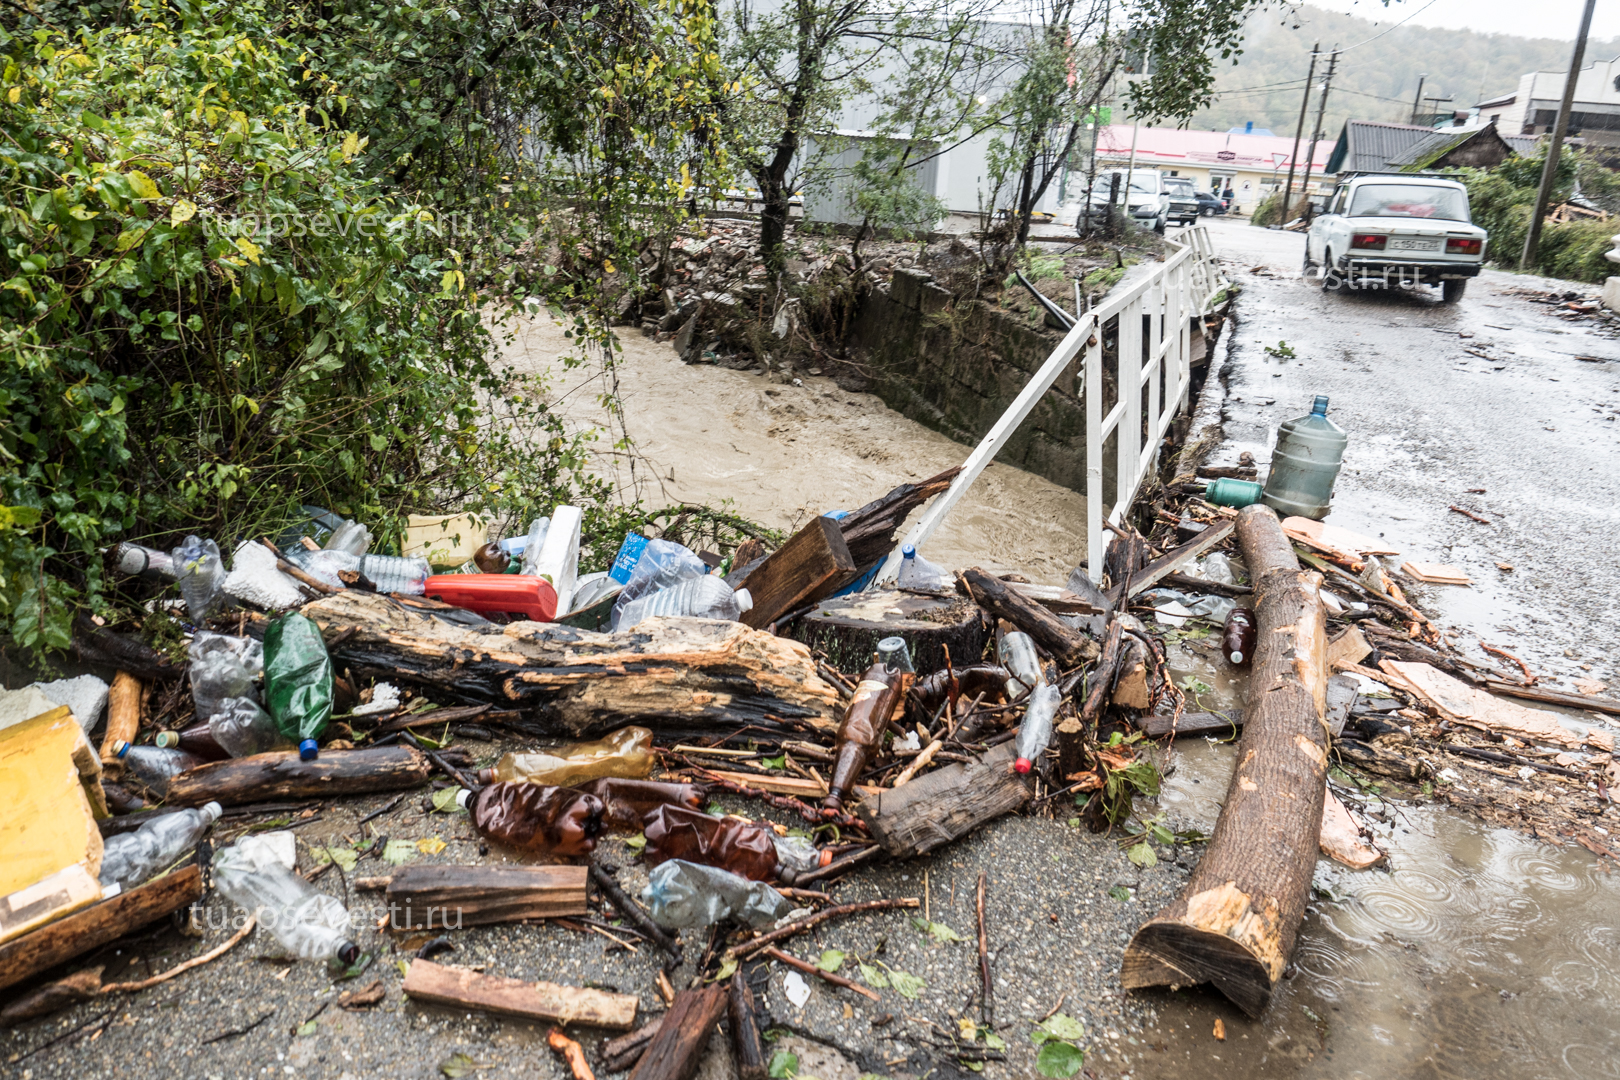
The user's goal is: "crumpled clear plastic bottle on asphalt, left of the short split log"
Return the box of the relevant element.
[214,845,360,963]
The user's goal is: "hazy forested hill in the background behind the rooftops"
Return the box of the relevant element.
[1166,0,1620,138]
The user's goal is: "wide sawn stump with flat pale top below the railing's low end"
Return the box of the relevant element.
[787,589,990,675]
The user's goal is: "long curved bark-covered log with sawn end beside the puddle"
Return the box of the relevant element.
[1119,505,1327,1017]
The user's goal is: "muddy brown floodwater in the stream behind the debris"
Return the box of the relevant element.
[505,316,1085,585]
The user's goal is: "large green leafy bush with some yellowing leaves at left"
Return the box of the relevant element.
[0,0,619,649]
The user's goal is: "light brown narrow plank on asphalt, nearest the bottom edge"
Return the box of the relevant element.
[405,960,640,1031]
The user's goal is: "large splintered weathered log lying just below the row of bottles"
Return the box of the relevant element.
[303,589,842,735]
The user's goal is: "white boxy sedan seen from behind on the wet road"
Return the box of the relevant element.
[1304,173,1487,304]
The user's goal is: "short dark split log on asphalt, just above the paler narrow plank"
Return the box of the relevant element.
[387,865,588,929]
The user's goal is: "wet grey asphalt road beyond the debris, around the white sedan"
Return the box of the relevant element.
[1205,219,1620,690]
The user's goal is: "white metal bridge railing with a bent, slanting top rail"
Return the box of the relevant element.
[873,225,1228,583]
